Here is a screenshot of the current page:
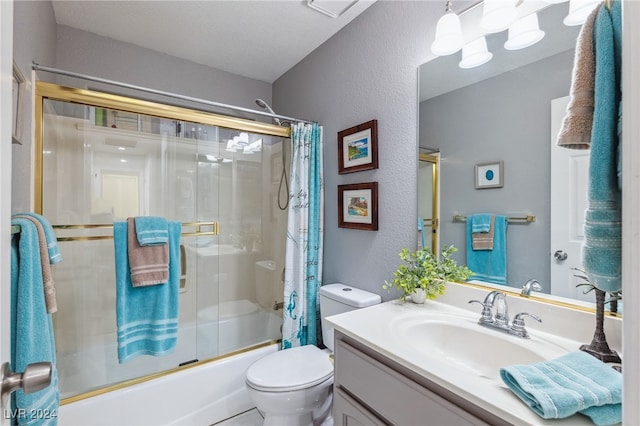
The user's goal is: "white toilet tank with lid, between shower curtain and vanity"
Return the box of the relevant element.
[320,283,382,352]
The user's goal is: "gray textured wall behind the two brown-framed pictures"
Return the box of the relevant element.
[273,1,472,300]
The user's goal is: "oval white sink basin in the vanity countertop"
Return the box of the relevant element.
[392,316,567,382]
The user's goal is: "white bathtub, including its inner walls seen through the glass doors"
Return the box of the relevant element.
[57,300,282,425]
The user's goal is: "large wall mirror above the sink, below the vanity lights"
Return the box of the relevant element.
[418,2,608,303]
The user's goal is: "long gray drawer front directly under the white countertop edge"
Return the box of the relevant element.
[335,339,487,426]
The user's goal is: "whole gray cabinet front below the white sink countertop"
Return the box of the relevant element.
[333,332,509,425]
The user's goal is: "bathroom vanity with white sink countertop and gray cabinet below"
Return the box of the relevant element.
[327,287,620,426]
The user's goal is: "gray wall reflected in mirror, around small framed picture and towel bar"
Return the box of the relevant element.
[420,50,574,292]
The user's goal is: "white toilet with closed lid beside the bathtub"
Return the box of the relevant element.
[246,284,381,426]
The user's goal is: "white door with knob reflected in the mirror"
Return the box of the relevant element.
[549,96,595,302]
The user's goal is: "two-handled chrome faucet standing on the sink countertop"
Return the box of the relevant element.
[469,290,542,339]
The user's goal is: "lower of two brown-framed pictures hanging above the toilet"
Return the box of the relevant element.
[338,182,378,231]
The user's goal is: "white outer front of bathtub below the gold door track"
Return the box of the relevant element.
[58,344,278,426]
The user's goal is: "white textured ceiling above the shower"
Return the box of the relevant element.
[53,0,375,83]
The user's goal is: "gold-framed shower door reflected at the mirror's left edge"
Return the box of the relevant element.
[418,149,440,253]
